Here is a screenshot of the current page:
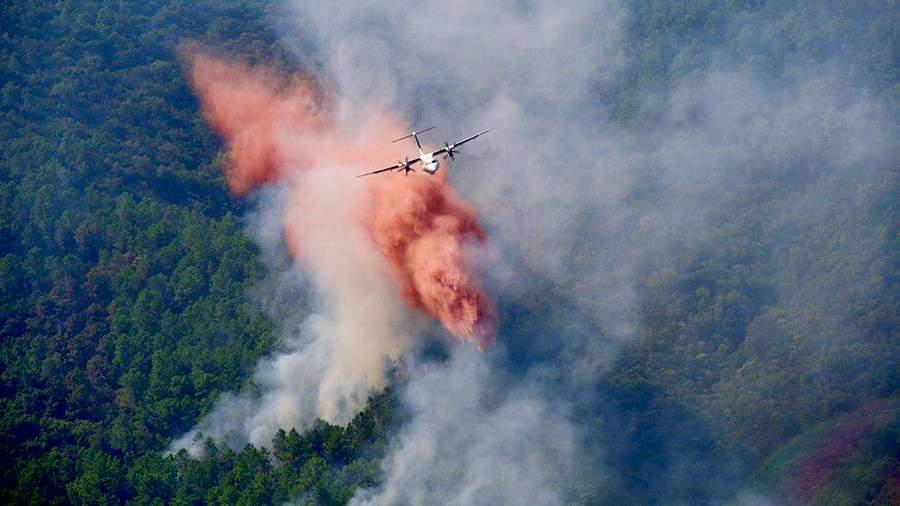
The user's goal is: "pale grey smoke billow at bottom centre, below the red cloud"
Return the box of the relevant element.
[353,347,592,505]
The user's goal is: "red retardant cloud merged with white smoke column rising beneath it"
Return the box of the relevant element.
[167,47,497,447]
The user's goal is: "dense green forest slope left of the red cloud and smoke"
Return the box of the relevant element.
[0,1,277,504]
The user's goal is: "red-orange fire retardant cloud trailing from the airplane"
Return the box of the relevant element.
[184,48,497,349]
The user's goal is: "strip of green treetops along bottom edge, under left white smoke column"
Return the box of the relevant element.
[113,391,397,505]
